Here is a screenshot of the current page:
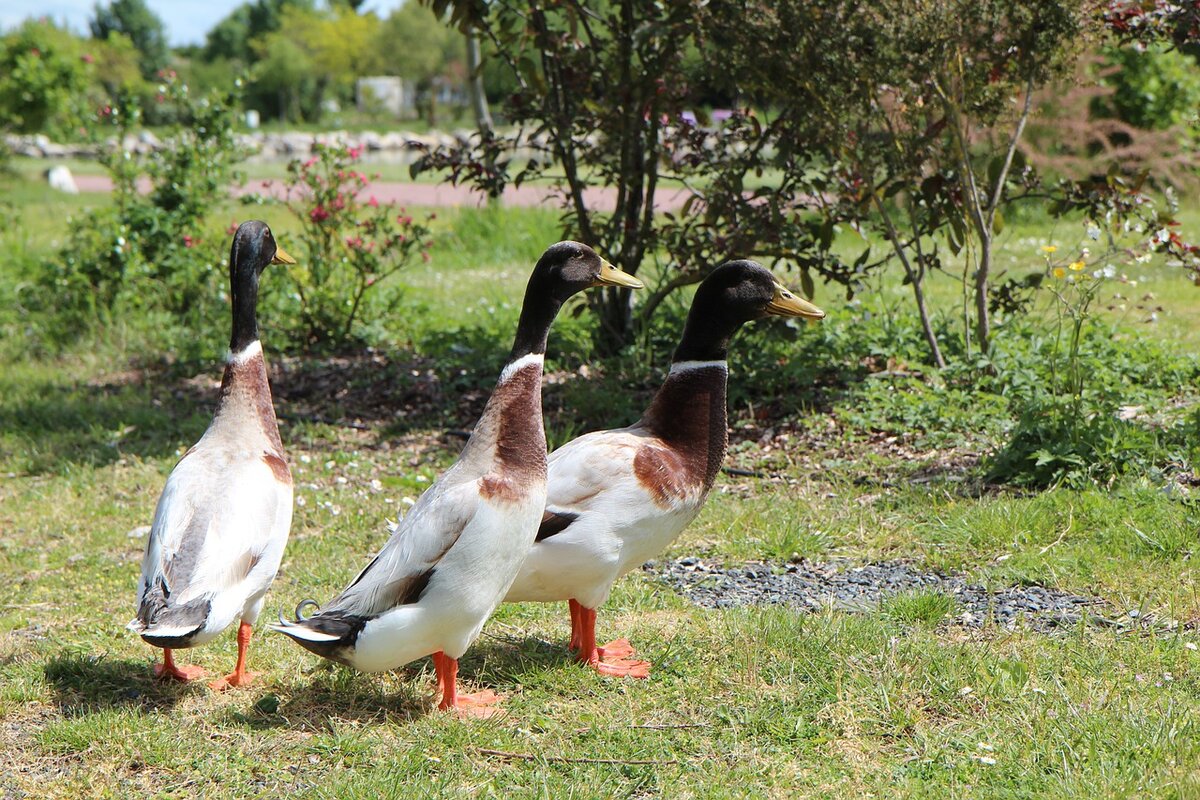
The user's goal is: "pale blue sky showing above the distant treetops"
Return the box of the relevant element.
[0,0,403,47]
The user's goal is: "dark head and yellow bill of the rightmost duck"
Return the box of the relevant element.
[674,260,826,361]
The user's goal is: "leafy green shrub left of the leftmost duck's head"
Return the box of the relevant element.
[43,71,242,341]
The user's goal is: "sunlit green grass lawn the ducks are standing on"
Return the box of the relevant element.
[0,172,1200,800]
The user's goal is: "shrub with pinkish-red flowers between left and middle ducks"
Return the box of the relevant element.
[274,144,432,350]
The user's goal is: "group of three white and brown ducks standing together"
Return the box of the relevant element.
[128,221,824,716]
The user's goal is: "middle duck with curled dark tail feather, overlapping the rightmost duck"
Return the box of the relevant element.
[274,241,642,717]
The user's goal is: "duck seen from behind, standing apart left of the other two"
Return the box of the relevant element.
[127,219,295,691]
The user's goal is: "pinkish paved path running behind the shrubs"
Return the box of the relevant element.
[74,175,688,211]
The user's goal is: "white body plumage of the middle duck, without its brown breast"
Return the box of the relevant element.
[275,354,546,672]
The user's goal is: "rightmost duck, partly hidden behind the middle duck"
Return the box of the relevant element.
[504,260,824,678]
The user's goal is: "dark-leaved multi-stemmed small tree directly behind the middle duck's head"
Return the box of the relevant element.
[414,0,744,351]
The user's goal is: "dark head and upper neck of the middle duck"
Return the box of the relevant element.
[510,241,644,360]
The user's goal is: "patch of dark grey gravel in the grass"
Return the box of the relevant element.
[642,557,1161,632]
